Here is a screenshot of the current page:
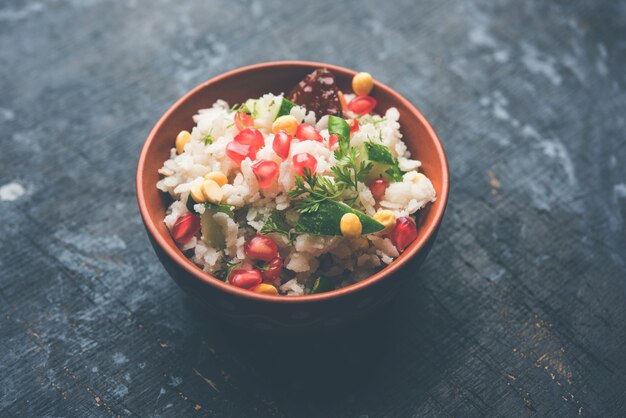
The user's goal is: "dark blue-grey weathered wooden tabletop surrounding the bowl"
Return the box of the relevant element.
[0,0,626,417]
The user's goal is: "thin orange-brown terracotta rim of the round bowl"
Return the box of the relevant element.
[136,61,450,303]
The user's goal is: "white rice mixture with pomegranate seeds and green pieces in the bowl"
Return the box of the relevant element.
[157,68,436,296]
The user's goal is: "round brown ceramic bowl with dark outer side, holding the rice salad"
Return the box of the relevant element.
[137,61,448,332]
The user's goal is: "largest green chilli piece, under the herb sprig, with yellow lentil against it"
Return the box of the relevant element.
[296,200,385,236]
